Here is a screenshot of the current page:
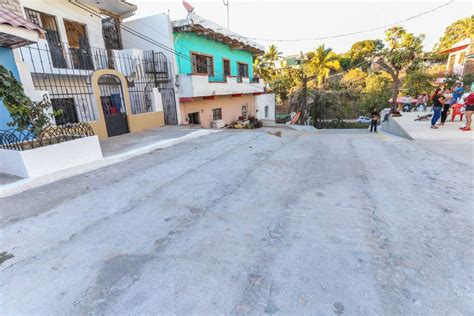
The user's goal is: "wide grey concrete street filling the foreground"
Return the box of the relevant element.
[0,129,474,315]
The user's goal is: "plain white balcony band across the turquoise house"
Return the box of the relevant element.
[179,74,265,98]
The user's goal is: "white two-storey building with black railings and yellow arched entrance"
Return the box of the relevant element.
[9,0,178,137]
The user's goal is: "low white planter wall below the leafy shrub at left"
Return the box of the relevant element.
[0,135,102,178]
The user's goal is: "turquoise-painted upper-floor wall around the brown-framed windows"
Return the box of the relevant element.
[173,32,253,81]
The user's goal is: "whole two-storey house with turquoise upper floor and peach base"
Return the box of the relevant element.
[172,13,275,127]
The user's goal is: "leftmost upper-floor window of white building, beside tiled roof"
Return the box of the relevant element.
[25,8,67,68]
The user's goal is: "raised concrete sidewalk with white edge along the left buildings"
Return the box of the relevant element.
[0,126,220,198]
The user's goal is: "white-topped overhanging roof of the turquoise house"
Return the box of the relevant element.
[172,13,265,55]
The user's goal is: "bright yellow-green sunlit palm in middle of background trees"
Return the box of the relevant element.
[308,45,341,88]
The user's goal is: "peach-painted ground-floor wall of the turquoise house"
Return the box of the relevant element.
[181,95,255,128]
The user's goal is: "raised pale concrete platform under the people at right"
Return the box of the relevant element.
[382,112,474,140]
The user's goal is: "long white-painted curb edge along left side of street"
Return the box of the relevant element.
[0,129,221,198]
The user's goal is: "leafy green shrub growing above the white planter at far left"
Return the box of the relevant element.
[0,65,51,135]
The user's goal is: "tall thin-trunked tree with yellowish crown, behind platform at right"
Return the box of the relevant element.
[372,26,424,107]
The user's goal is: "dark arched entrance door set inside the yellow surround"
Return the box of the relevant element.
[98,74,129,137]
